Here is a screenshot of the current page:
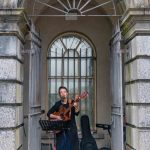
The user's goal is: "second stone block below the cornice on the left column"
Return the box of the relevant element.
[0,59,23,82]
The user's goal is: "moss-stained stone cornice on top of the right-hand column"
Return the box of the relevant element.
[121,8,150,43]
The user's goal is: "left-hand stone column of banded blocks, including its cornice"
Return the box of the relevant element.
[0,7,26,150]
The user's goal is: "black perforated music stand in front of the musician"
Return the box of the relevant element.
[39,120,70,150]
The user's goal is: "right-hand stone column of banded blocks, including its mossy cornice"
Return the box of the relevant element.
[122,7,150,150]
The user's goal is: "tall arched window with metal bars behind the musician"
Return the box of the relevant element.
[47,33,96,129]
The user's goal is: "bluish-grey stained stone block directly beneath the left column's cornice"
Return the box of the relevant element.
[0,36,24,60]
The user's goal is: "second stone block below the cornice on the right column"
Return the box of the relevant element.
[125,59,150,82]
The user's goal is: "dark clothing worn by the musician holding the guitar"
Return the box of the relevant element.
[47,100,79,150]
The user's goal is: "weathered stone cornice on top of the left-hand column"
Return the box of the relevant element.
[0,8,30,42]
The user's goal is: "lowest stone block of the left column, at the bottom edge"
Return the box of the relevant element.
[0,128,23,150]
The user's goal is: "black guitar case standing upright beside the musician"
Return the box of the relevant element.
[80,115,98,150]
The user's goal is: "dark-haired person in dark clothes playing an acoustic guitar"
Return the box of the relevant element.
[47,86,79,150]
